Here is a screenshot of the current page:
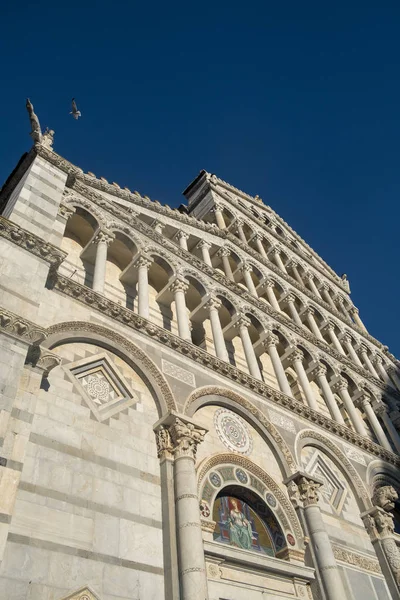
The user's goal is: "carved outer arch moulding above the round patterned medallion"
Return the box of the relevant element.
[183,386,298,477]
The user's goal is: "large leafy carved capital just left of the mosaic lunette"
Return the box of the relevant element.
[154,413,207,460]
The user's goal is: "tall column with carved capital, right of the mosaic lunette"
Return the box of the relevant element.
[285,473,347,600]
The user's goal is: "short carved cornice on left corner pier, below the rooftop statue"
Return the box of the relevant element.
[0,216,67,269]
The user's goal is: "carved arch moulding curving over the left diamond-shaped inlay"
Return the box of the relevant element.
[42,321,177,417]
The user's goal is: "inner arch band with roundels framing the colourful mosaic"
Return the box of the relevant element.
[197,452,304,549]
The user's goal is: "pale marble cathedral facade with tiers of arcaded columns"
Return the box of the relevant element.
[0,113,400,600]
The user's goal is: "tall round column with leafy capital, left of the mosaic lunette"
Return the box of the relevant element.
[157,415,208,600]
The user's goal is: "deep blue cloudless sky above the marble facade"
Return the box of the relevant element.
[0,0,400,357]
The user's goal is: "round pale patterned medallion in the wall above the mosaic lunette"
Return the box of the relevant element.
[214,408,253,454]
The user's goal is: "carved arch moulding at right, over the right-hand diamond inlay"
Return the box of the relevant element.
[295,429,372,512]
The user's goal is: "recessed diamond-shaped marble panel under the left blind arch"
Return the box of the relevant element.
[67,354,139,421]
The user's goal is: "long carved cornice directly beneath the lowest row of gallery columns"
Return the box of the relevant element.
[53,274,400,466]
